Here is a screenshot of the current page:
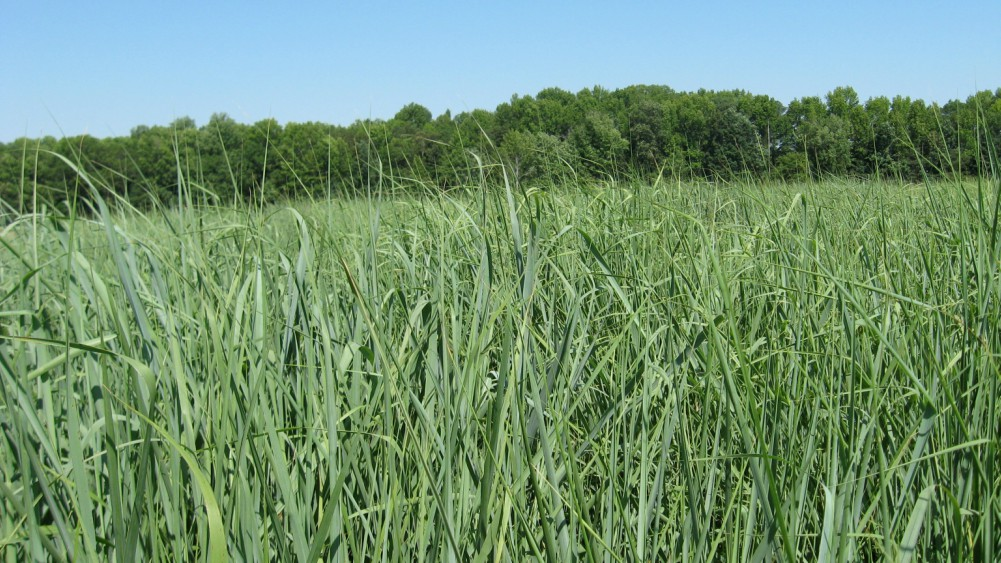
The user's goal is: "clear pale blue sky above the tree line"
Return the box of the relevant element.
[0,0,1001,142]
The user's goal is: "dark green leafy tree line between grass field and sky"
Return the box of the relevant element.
[0,85,1001,207]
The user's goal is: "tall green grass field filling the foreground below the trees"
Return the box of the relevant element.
[0,166,1001,561]
